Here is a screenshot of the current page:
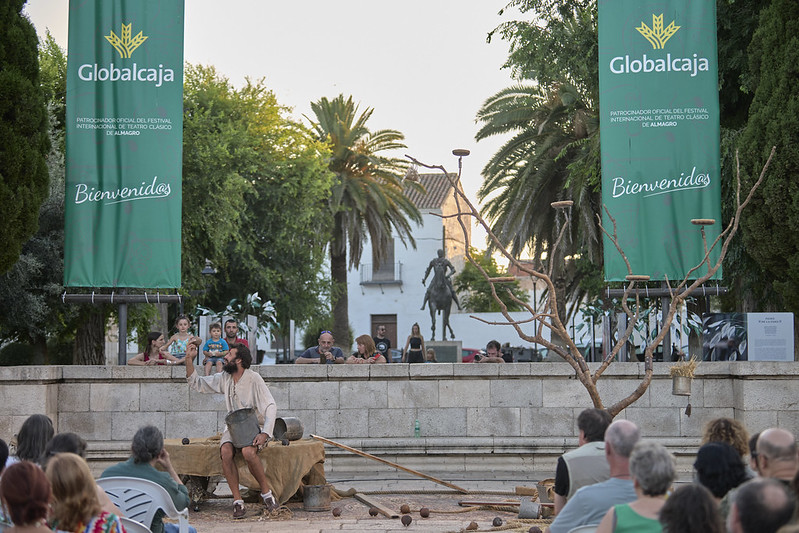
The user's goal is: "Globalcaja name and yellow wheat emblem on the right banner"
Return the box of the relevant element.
[608,13,710,78]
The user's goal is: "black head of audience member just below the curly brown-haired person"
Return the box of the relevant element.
[694,442,749,502]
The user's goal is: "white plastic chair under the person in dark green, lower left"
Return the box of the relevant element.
[97,477,189,533]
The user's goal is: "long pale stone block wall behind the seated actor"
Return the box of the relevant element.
[0,362,799,471]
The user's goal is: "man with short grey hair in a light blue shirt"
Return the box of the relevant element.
[548,420,641,533]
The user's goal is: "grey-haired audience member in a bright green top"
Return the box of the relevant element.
[596,442,676,533]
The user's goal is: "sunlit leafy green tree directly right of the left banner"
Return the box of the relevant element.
[183,66,332,336]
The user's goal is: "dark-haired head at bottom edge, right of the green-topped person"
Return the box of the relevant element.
[658,483,725,533]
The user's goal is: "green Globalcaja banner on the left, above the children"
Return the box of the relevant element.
[64,0,184,288]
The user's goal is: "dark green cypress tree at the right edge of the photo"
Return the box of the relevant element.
[739,0,799,312]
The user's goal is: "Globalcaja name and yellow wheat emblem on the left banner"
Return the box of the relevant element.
[78,23,175,87]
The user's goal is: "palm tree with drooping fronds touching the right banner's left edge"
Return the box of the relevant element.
[476,83,602,322]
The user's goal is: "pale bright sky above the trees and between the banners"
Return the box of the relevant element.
[25,0,518,248]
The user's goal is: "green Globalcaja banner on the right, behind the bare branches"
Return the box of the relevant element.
[598,0,721,281]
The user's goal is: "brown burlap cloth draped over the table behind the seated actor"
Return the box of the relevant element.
[164,435,325,504]
